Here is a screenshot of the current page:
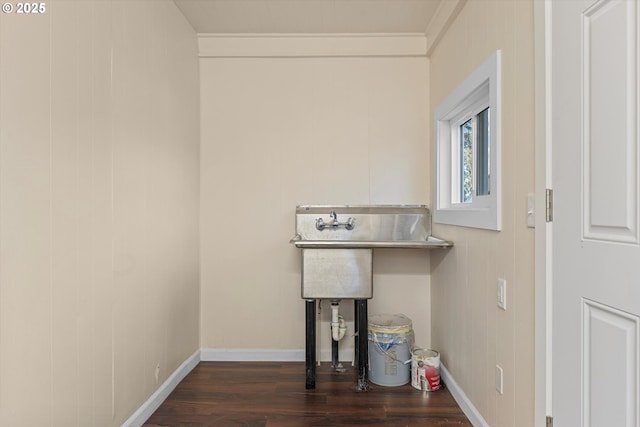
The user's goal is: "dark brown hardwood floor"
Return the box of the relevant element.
[144,362,471,427]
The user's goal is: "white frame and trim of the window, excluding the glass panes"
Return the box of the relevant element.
[433,50,502,231]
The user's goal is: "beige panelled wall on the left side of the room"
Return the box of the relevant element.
[0,0,199,427]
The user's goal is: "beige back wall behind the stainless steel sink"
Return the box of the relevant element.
[200,49,430,360]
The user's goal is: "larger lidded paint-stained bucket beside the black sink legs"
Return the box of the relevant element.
[368,314,414,386]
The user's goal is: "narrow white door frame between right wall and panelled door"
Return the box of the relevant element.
[533,0,553,427]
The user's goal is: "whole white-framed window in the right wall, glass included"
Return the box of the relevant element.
[433,51,501,230]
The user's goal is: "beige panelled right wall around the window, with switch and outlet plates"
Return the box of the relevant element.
[430,0,535,427]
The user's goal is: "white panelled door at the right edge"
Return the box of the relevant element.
[549,0,640,427]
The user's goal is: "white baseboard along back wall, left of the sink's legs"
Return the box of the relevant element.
[200,348,304,362]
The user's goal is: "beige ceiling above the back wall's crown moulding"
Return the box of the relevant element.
[174,0,447,34]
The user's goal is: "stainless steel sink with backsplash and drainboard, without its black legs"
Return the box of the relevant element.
[290,205,453,299]
